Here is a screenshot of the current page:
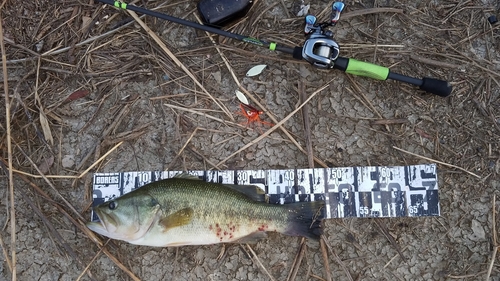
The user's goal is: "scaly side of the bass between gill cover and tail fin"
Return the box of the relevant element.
[145,180,288,244]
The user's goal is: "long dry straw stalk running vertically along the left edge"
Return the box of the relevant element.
[0,7,17,281]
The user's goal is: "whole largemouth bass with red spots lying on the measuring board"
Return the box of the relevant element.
[87,174,324,247]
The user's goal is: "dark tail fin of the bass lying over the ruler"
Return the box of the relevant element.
[284,201,325,240]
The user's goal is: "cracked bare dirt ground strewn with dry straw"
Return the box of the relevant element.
[0,0,500,280]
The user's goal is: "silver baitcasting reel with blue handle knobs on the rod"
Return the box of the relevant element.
[302,2,344,68]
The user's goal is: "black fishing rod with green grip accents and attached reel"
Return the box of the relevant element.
[97,0,452,97]
